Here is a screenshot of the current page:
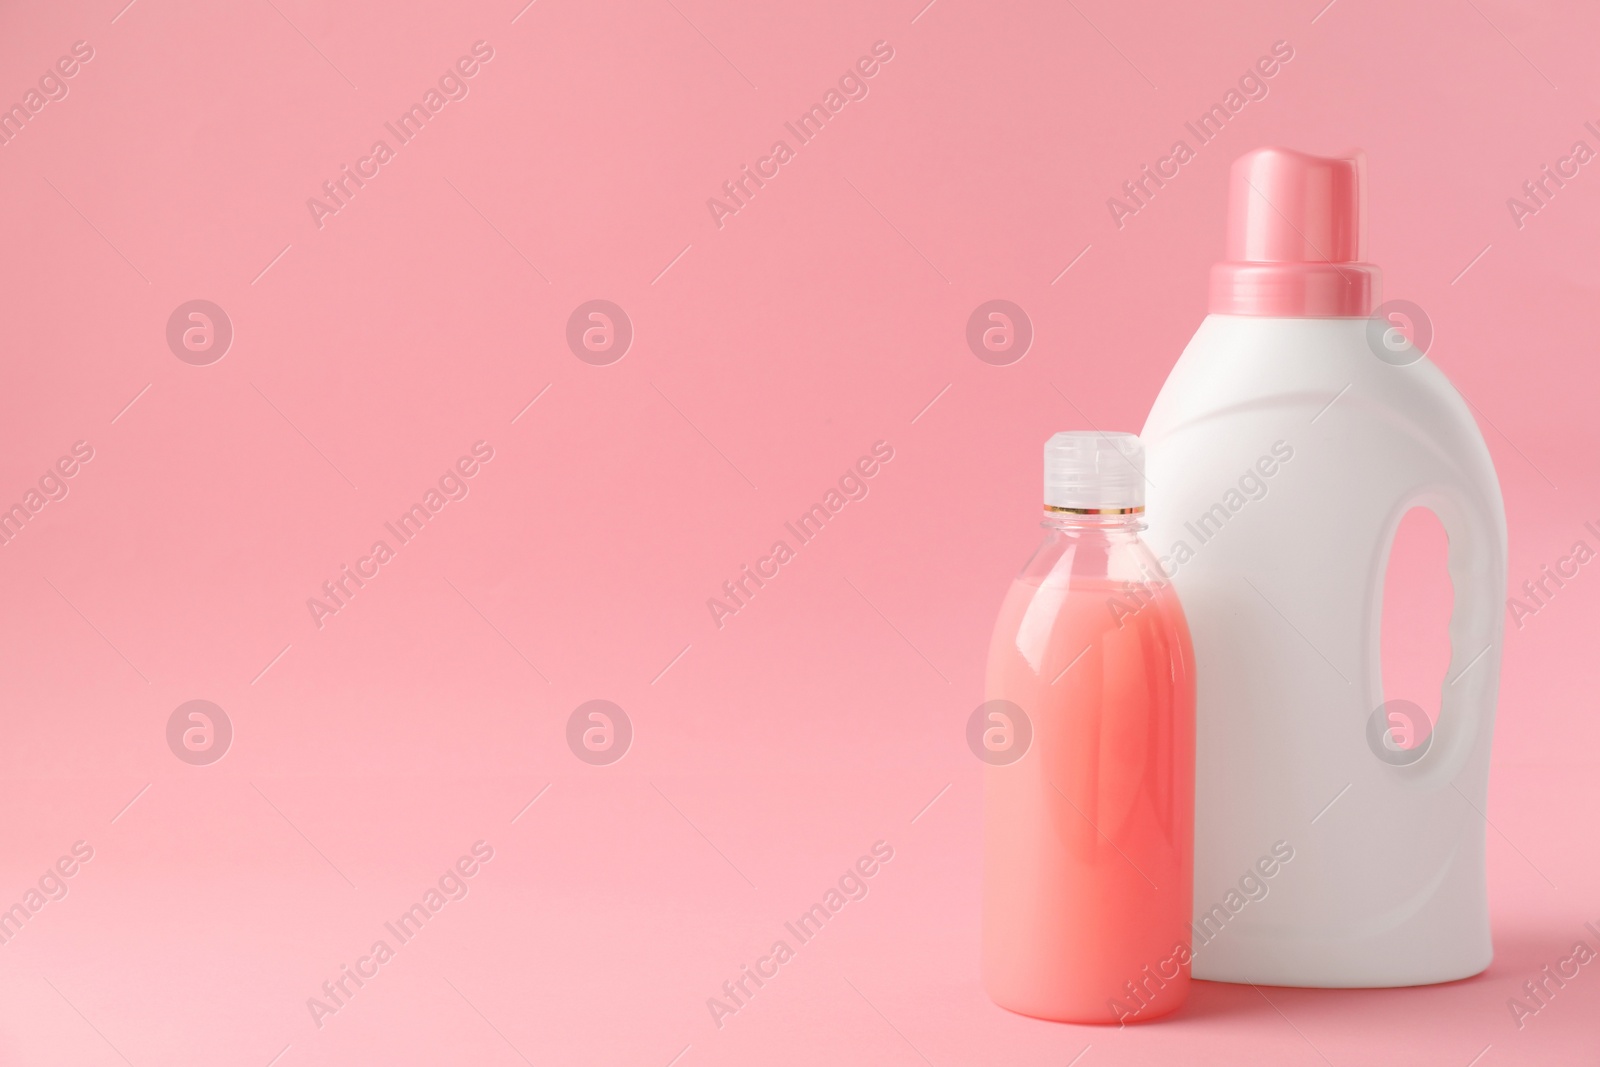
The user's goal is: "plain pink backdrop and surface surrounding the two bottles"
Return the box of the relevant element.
[0,0,1600,1067]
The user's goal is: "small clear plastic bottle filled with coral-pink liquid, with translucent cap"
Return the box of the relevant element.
[982,430,1195,1024]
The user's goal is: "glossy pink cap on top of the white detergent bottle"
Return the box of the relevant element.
[1211,149,1379,318]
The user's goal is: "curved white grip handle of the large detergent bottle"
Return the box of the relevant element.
[1374,485,1506,787]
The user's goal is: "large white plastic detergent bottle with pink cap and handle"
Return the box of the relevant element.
[1141,149,1506,987]
